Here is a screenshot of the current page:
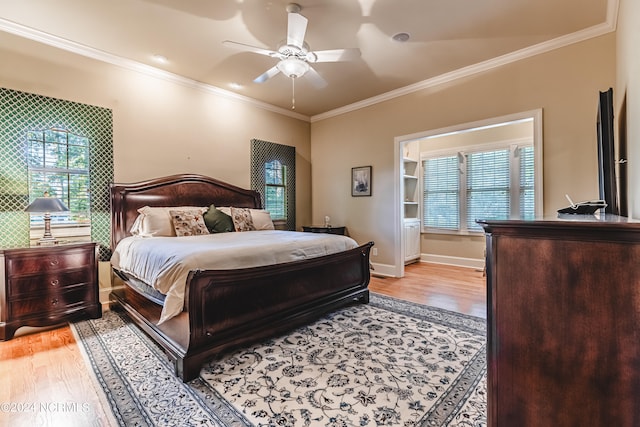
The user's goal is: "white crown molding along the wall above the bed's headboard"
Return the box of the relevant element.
[0,18,309,122]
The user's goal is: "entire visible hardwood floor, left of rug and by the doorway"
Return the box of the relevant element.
[0,263,486,427]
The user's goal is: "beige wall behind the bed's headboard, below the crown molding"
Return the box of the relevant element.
[0,32,311,224]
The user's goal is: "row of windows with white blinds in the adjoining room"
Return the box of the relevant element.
[422,144,535,232]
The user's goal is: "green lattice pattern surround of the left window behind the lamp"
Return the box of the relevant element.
[0,88,113,260]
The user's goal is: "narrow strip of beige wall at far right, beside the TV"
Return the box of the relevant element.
[614,0,640,219]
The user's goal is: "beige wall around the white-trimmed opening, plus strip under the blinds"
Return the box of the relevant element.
[311,33,616,272]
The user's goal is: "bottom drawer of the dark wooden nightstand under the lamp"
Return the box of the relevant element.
[10,285,91,317]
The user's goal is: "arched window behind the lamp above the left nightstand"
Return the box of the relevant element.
[27,129,90,226]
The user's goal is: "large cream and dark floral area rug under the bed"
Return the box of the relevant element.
[72,294,486,427]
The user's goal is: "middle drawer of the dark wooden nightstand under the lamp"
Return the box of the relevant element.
[8,268,93,300]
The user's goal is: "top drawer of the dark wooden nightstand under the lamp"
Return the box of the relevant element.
[6,249,95,277]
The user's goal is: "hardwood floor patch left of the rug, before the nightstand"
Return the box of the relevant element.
[0,325,110,427]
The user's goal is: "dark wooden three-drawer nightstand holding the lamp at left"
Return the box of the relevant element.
[0,242,102,341]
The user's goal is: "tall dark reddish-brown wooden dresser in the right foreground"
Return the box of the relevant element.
[480,216,640,427]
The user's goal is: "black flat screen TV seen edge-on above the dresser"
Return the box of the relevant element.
[597,88,620,215]
